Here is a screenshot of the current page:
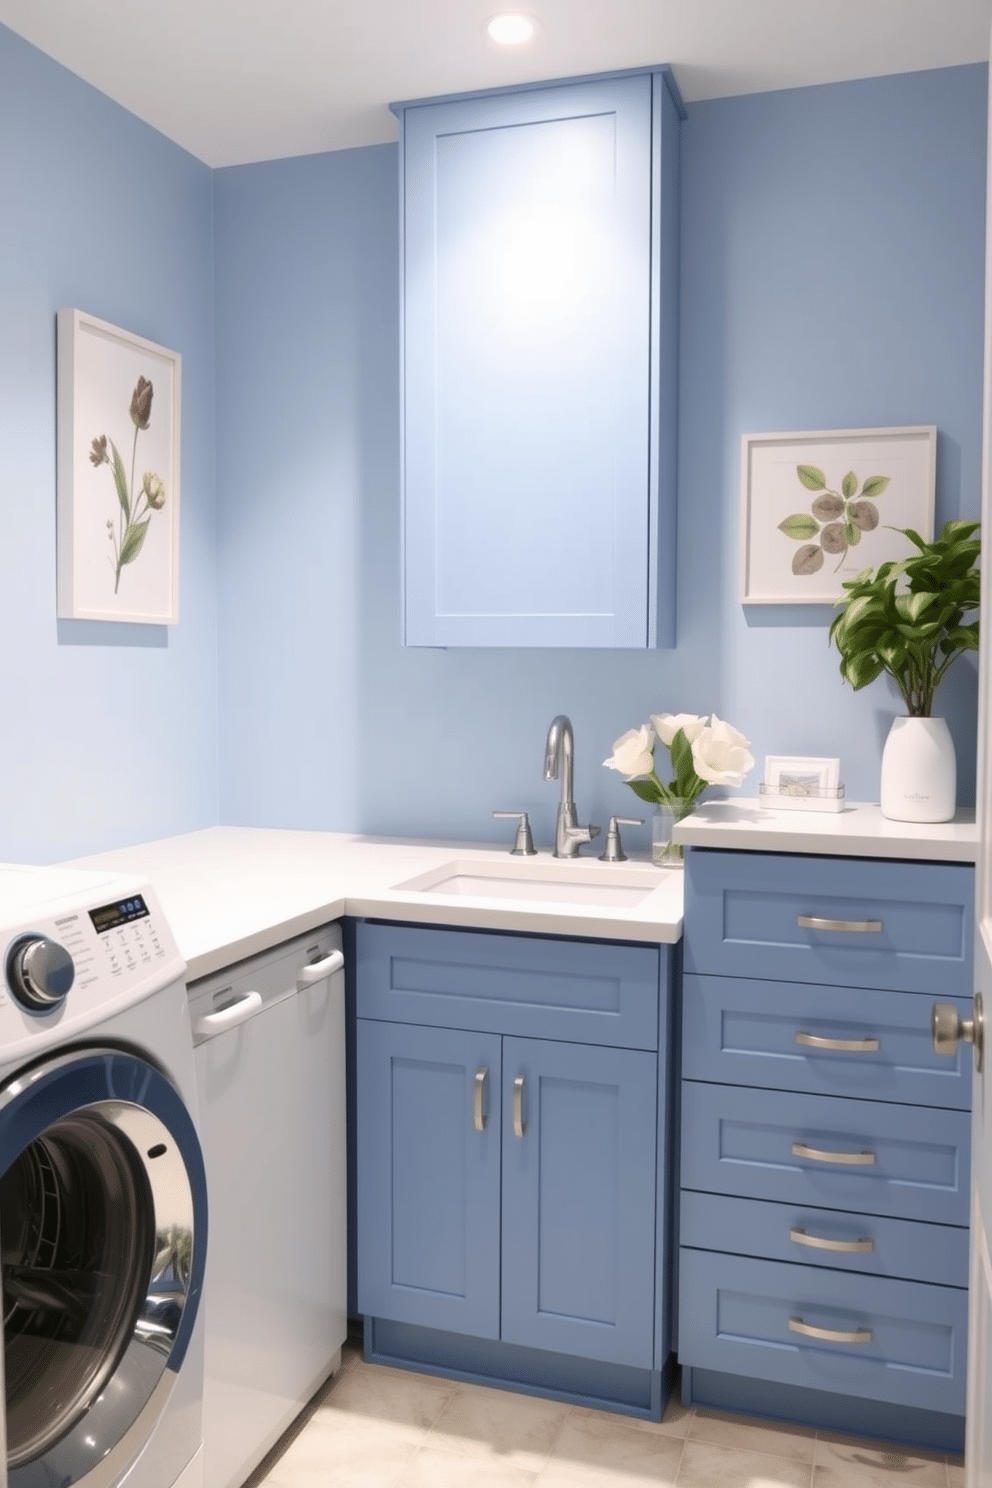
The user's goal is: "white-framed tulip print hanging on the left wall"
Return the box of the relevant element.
[57,310,181,625]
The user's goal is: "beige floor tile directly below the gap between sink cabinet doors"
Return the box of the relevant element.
[428,1385,570,1473]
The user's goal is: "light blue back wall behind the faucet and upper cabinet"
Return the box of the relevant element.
[216,67,986,844]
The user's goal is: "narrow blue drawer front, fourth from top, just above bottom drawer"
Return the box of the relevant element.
[680,1190,968,1287]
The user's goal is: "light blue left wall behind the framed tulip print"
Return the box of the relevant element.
[0,27,217,862]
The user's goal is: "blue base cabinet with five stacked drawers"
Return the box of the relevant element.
[678,848,974,1451]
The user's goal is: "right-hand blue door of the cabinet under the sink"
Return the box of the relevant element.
[501,1037,657,1369]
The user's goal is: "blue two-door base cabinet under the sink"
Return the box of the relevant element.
[355,923,671,1417]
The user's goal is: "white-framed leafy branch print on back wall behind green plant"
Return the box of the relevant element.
[741,424,937,604]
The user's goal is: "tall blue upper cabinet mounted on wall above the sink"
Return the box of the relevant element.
[396,70,681,647]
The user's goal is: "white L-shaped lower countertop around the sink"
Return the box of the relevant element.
[64,827,683,981]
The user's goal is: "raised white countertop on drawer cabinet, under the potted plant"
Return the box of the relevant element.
[675,798,979,863]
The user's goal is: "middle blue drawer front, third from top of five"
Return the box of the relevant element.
[681,1080,971,1226]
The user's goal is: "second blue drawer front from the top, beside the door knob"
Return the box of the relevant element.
[683,976,971,1110]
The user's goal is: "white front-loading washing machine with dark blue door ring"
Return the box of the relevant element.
[0,866,207,1488]
